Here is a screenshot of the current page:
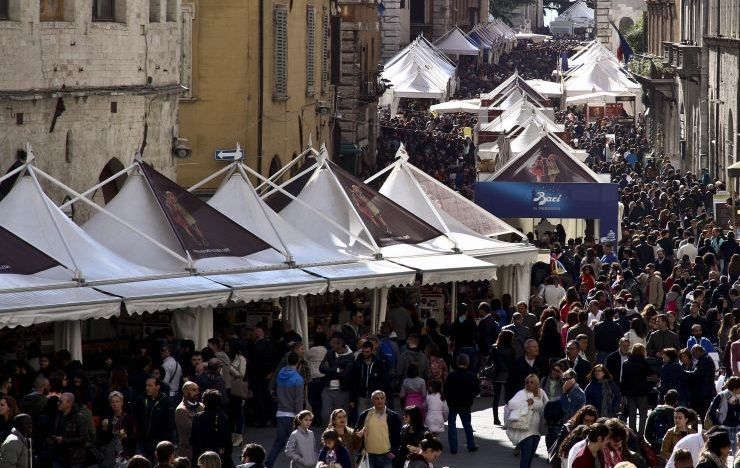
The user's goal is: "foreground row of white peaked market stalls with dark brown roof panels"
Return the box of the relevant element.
[0,146,537,359]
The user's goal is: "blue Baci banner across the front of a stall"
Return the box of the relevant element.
[475,182,619,240]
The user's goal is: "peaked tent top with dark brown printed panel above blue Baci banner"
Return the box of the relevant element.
[487,133,601,183]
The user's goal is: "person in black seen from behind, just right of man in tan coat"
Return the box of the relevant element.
[190,390,234,468]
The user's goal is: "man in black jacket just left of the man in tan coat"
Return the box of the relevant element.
[136,377,174,460]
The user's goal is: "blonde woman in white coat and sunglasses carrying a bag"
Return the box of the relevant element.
[504,374,548,468]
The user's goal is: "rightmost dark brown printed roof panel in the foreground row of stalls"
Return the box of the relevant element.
[328,161,442,247]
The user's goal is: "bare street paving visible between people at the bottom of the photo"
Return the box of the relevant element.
[234,397,547,468]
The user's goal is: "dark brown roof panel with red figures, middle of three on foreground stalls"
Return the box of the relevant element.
[141,162,271,259]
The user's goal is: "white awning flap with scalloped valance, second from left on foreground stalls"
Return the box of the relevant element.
[96,276,231,314]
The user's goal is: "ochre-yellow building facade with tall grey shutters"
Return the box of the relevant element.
[178,0,340,194]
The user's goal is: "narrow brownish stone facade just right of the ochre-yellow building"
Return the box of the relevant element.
[334,0,382,173]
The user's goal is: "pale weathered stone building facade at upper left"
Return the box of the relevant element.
[0,0,182,221]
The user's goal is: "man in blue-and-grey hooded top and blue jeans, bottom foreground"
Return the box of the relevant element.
[265,351,304,468]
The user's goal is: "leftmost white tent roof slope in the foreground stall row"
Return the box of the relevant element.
[0,177,166,282]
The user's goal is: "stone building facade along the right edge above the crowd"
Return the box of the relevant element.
[638,0,740,179]
